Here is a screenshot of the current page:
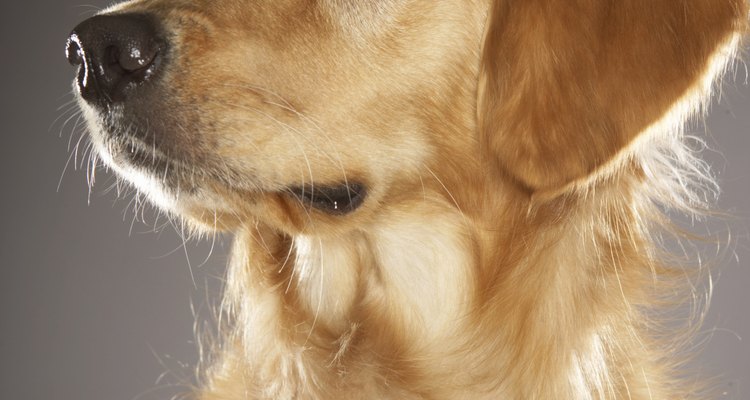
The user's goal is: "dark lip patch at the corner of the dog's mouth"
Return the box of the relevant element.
[292,182,367,215]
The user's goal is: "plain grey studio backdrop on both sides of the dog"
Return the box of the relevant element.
[0,0,750,400]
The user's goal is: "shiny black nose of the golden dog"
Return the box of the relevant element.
[65,14,167,106]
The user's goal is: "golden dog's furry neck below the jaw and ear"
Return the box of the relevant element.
[203,174,668,398]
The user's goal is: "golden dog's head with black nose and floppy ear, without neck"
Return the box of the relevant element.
[67,0,743,232]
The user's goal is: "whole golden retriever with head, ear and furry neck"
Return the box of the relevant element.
[67,0,748,400]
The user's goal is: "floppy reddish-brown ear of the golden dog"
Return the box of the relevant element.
[478,0,747,191]
